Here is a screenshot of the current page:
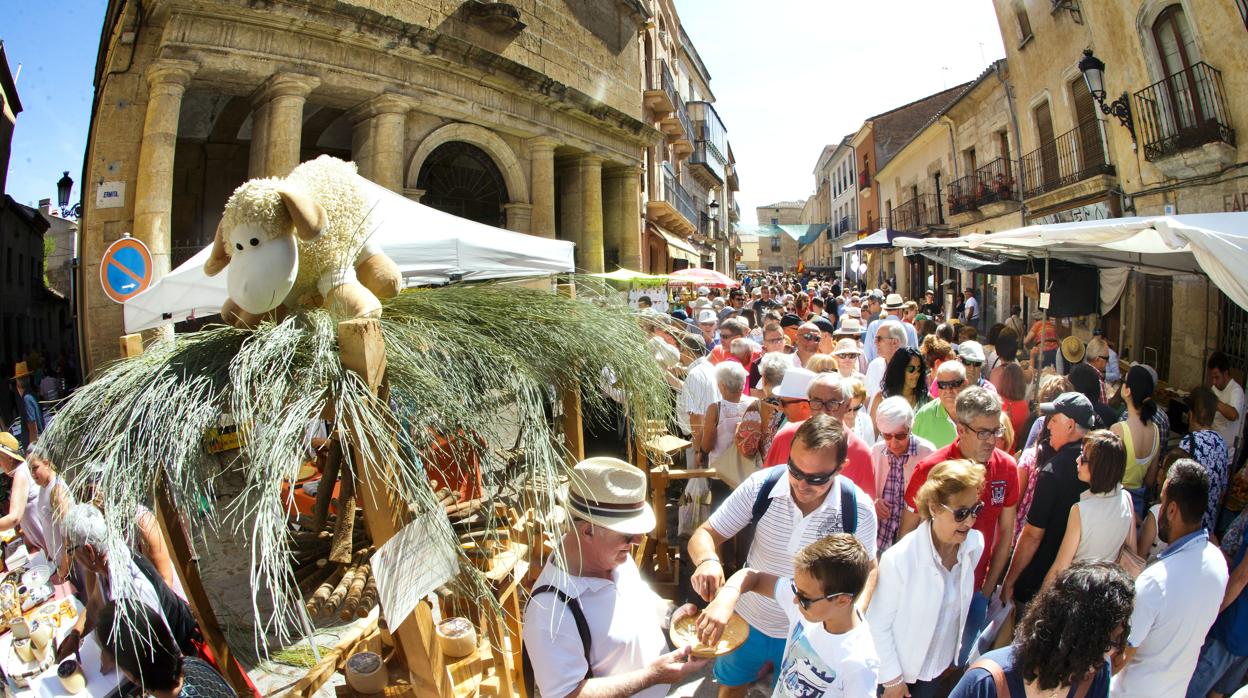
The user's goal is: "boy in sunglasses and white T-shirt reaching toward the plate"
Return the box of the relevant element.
[698,533,880,698]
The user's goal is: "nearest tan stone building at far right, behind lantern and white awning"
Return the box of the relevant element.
[993,0,1248,388]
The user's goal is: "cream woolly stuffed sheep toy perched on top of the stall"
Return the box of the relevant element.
[203,155,402,327]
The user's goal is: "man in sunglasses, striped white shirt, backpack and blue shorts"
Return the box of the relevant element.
[689,415,876,698]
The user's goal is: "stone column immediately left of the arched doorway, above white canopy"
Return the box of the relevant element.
[347,94,412,191]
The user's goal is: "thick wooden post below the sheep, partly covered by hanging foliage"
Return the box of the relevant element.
[338,318,452,698]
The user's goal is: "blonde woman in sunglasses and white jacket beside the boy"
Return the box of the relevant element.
[866,461,983,698]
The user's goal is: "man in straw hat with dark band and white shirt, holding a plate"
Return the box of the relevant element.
[524,458,706,698]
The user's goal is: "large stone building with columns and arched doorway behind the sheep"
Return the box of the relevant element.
[81,0,735,366]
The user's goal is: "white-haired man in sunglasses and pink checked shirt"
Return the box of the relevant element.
[871,395,936,554]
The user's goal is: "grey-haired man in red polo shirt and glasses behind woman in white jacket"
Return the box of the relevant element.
[897,386,1018,664]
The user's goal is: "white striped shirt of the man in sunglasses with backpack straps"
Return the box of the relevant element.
[706,466,876,638]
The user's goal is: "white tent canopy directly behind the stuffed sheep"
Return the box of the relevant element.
[125,181,575,332]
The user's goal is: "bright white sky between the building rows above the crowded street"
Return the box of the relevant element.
[675,0,1006,224]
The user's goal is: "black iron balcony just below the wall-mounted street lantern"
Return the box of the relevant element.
[1022,119,1114,199]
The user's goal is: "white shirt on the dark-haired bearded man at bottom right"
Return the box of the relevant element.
[1109,529,1228,698]
